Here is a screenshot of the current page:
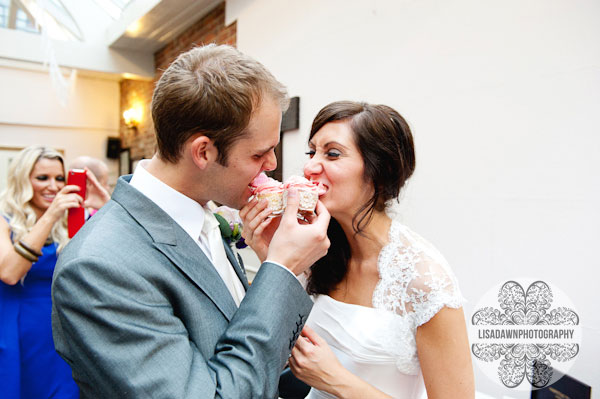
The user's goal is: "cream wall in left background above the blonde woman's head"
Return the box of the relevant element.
[0,65,120,191]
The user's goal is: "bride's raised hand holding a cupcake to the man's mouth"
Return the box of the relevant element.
[240,198,281,262]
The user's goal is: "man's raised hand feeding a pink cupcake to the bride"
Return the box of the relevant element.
[267,188,330,276]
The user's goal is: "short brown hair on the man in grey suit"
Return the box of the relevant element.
[152,44,289,165]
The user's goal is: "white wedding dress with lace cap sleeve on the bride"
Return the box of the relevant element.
[306,220,464,399]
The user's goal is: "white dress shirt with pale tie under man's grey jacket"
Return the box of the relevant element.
[129,160,246,306]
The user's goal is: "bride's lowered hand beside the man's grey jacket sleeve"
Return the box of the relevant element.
[289,326,348,393]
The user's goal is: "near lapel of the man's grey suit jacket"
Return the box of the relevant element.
[112,176,237,321]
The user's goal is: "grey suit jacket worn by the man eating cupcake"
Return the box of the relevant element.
[52,176,312,399]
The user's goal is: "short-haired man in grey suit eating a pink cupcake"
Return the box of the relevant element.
[52,45,329,398]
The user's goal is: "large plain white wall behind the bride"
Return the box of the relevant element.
[227,0,600,397]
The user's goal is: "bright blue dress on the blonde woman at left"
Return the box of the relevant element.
[0,222,79,399]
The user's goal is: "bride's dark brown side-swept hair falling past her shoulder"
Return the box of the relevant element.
[306,101,416,294]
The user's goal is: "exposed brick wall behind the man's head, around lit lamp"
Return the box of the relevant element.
[120,3,237,160]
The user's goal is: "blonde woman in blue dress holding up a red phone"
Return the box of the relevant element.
[0,146,107,399]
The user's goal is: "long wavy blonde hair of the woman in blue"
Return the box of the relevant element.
[0,146,69,250]
